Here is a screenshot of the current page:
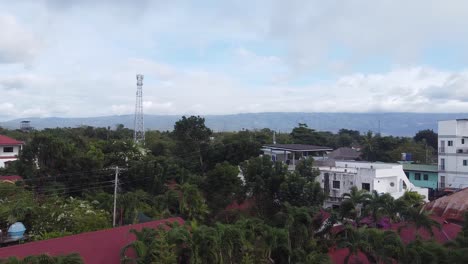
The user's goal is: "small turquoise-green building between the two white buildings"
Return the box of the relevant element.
[403,163,439,197]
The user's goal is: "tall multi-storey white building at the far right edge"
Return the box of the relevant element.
[438,119,468,189]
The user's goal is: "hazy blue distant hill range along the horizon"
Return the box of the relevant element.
[0,113,468,136]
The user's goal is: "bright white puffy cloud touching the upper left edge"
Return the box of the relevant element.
[0,14,40,64]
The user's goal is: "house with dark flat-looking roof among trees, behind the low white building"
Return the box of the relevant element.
[262,144,333,170]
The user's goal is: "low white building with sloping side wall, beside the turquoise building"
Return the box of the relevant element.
[317,161,428,207]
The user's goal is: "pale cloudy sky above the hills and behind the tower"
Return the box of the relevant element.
[0,0,468,121]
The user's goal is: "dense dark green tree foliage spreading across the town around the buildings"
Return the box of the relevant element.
[0,116,452,263]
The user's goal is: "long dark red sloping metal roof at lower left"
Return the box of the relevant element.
[0,217,184,264]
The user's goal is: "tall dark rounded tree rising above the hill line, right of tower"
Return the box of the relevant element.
[172,116,213,172]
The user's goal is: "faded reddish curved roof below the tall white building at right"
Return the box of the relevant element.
[425,188,468,223]
